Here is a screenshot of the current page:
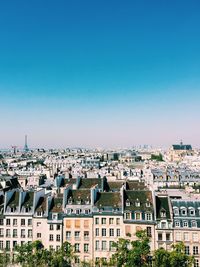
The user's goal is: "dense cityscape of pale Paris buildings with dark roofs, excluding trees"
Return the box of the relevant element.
[0,136,200,267]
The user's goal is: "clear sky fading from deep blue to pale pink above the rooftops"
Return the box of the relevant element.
[0,0,200,147]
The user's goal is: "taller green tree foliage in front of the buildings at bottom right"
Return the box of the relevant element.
[111,230,194,267]
